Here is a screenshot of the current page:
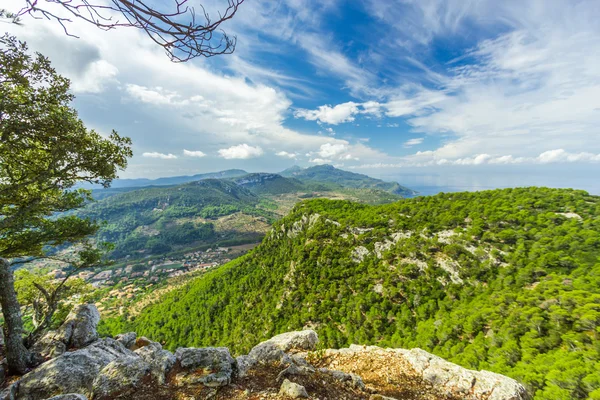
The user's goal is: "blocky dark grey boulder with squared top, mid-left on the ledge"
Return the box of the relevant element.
[175,347,235,387]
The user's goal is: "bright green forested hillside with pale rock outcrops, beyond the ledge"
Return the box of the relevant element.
[130,188,600,399]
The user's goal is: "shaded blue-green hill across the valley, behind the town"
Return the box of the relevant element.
[78,179,275,258]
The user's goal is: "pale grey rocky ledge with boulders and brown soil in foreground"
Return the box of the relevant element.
[0,304,527,400]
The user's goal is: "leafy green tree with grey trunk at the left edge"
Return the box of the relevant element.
[0,35,132,373]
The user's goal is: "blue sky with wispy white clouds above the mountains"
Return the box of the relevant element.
[2,0,600,194]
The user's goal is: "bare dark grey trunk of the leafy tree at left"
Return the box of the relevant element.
[0,257,31,374]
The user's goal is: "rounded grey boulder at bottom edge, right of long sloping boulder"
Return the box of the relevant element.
[92,355,150,400]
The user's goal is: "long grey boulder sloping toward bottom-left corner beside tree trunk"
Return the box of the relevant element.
[17,338,135,400]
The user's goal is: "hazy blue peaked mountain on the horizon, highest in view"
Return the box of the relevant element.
[280,165,417,196]
